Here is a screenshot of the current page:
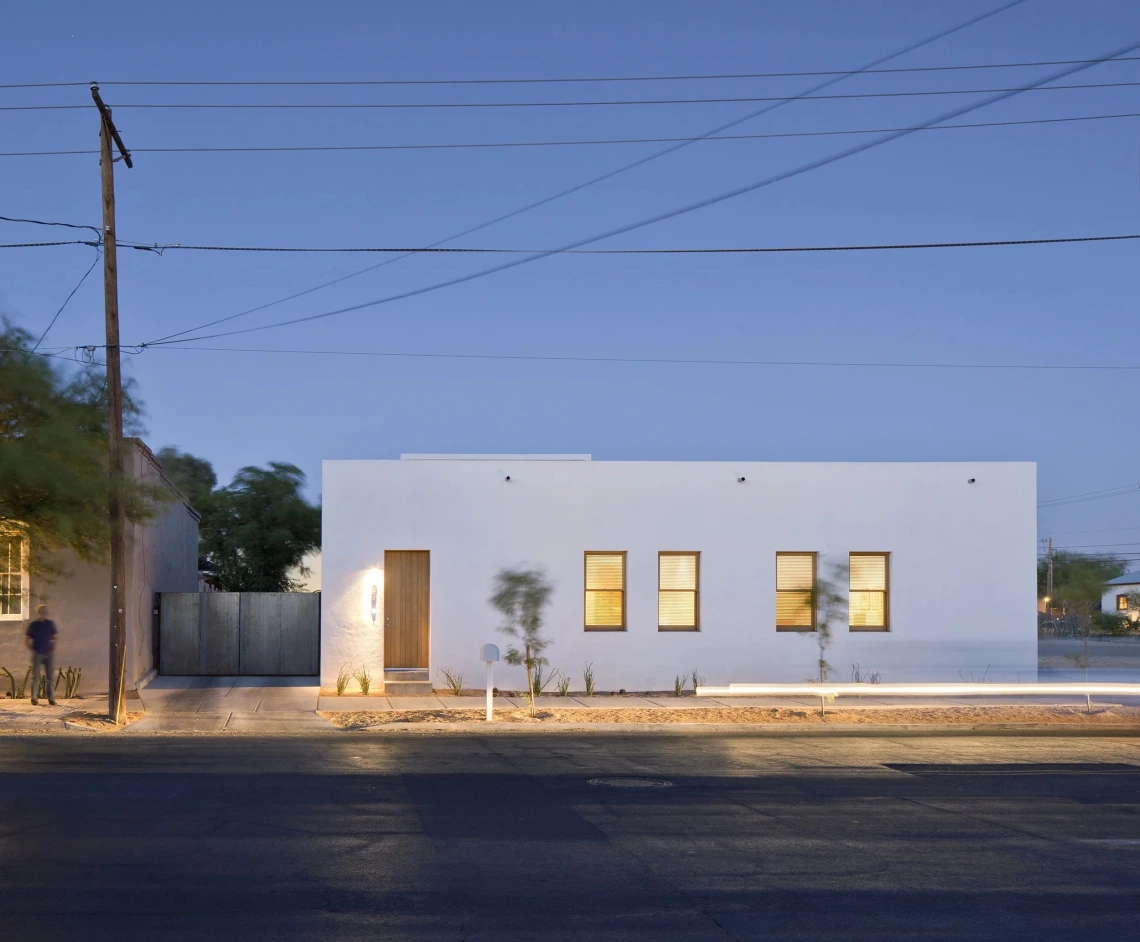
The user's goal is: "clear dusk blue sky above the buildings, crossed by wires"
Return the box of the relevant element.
[0,0,1140,553]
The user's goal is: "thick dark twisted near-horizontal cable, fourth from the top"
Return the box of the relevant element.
[108,234,1140,255]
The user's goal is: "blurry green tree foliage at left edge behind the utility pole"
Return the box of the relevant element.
[0,320,153,578]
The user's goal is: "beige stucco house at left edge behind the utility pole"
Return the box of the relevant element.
[0,438,198,696]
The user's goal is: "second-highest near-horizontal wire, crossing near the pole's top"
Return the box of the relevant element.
[8,82,1140,112]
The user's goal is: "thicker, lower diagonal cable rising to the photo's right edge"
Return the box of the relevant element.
[147,33,1140,346]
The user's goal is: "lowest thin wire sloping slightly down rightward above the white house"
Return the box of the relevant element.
[140,338,1140,373]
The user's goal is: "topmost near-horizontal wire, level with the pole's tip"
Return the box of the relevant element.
[0,56,1140,88]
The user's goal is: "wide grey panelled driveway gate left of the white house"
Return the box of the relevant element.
[158,592,320,676]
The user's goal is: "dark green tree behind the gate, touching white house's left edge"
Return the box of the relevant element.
[200,462,320,592]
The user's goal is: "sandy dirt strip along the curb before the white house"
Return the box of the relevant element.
[320,705,1140,730]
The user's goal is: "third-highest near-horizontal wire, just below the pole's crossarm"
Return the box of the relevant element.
[8,112,1140,157]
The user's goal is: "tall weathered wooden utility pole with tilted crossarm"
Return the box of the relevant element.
[91,84,133,725]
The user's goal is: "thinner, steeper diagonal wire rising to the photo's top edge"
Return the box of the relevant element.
[140,0,1025,340]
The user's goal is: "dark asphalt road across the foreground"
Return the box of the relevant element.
[0,733,1140,942]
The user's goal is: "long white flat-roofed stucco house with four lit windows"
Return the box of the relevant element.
[320,455,1037,690]
